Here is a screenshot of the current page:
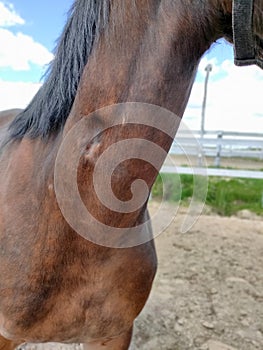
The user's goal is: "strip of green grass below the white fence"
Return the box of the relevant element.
[152,174,263,216]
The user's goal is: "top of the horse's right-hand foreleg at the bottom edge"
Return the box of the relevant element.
[83,329,132,350]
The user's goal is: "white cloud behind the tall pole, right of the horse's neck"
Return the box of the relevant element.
[184,60,263,133]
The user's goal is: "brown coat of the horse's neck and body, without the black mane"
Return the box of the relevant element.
[0,0,262,350]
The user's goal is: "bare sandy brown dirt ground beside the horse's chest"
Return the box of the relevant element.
[20,202,263,350]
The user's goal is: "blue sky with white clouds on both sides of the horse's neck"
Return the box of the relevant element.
[0,0,263,133]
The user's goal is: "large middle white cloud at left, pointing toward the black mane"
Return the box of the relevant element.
[0,28,53,71]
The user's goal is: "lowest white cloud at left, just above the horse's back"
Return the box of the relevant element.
[0,80,41,111]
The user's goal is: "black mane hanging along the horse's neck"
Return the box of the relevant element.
[9,0,109,139]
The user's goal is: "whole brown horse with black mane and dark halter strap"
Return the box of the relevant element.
[0,0,263,350]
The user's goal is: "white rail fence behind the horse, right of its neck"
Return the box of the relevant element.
[167,130,263,179]
